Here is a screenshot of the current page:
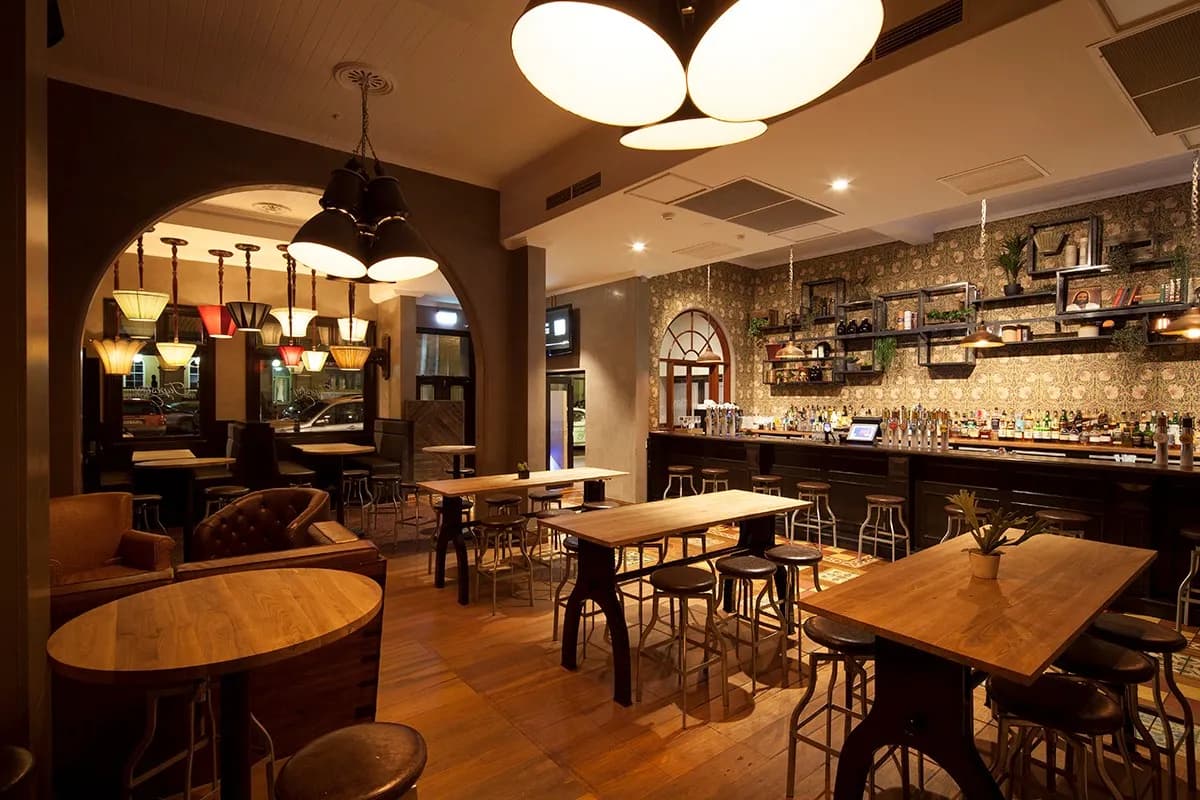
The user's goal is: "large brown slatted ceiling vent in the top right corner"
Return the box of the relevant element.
[1098,11,1200,136]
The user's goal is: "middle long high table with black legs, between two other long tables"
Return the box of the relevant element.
[541,489,811,705]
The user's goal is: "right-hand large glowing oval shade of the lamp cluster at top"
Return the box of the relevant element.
[688,0,883,122]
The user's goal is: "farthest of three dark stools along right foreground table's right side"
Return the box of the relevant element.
[1087,612,1196,796]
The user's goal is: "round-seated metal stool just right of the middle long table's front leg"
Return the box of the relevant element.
[634,566,730,727]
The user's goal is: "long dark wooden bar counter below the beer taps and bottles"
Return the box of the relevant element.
[647,431,1200,618]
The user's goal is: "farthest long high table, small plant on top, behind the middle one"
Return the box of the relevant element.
[418,467,629,606]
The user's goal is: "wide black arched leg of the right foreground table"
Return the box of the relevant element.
[834,638,1002,800]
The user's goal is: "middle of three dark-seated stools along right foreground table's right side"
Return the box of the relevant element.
[1046,633,1163,798]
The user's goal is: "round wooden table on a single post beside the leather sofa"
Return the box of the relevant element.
[46,570,383,800]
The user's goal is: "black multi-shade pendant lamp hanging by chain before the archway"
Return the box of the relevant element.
[288,65,438,283]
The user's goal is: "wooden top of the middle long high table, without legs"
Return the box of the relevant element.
[539,489,811,547]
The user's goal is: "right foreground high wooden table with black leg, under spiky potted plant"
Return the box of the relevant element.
[800,531,1156,800]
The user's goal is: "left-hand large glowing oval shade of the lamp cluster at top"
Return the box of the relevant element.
[511,0,688,127]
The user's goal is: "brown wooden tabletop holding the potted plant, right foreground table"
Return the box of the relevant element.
[800,531,1157,685]
